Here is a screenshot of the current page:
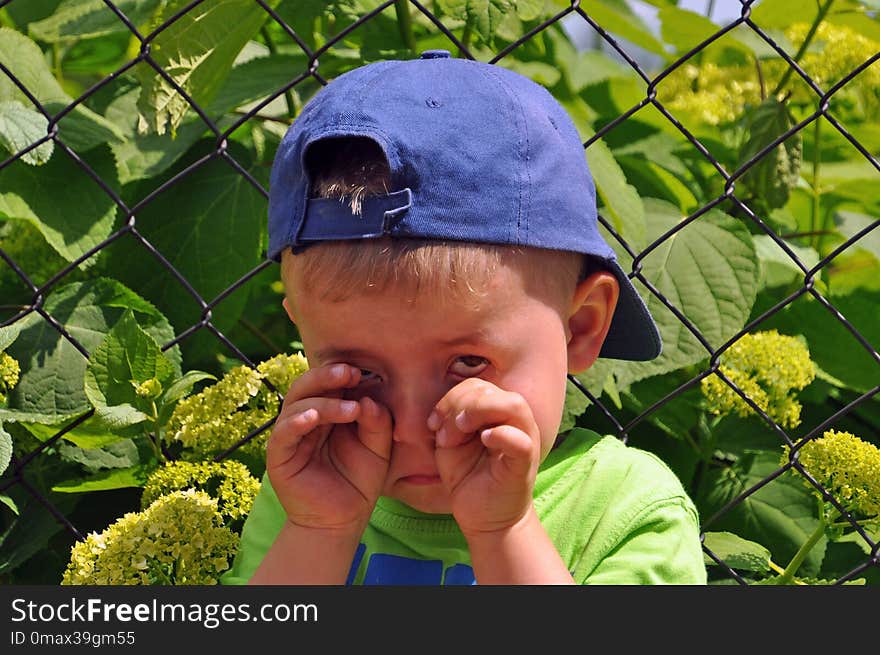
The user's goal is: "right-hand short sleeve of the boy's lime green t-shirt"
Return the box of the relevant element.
[581,498,706,585]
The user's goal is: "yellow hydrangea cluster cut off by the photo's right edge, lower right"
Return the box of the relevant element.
[783,430,880,518]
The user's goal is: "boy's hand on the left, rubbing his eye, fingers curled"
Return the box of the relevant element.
[266,364,391,536]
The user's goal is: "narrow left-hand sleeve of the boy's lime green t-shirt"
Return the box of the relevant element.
[220,474,287,585]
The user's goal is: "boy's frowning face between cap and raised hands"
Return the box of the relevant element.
[289,266,568,513]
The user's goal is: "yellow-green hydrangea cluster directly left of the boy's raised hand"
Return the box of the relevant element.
[165,353,309,460]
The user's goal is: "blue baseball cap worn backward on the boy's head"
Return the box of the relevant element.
[268,50,661,360]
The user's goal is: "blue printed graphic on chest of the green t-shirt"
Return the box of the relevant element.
[346,544,476,585]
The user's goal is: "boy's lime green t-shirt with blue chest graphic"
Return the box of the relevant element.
[221,428,706,585]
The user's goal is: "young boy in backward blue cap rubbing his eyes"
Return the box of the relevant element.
[223,51,705,584]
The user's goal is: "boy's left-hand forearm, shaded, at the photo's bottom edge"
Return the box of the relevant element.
[248,521,360,585]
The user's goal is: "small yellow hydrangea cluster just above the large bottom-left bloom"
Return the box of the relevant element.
[141,460,260,525]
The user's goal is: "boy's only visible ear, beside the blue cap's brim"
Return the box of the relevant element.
[566,271,620,373]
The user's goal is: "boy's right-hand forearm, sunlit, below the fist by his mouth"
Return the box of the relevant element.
[465,508,574,585]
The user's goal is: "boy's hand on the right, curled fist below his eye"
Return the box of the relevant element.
[428,378,541,536]
